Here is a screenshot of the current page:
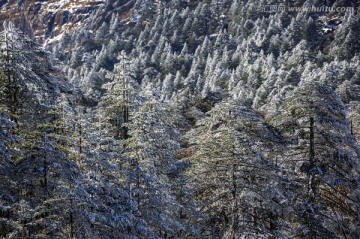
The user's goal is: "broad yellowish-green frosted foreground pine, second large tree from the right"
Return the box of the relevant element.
[187,101,291,238]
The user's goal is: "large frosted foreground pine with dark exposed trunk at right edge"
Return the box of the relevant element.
[273,80,360,238]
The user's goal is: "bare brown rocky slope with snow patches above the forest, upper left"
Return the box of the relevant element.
[0,0,179,45]
